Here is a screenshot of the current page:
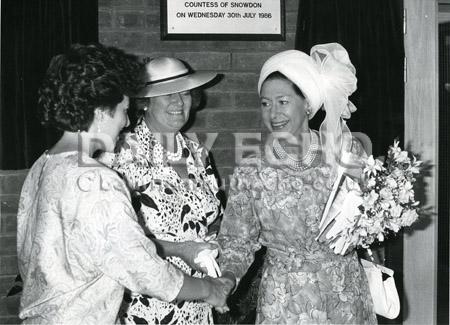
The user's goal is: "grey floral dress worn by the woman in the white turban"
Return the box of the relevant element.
[219,133,376,324]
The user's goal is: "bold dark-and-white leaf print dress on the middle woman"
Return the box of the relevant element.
[107,122,222,324]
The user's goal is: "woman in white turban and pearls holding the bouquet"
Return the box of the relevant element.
[218,43,376,324]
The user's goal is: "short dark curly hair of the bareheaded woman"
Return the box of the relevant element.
[39,44,143,132]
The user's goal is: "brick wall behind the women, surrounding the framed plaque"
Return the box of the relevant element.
[99,0,298,189]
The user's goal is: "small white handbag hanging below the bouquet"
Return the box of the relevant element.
[360,259,400,319]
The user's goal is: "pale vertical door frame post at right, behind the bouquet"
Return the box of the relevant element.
[402,0,439,324]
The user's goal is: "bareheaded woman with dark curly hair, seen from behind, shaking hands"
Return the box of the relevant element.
[17,45,231,324]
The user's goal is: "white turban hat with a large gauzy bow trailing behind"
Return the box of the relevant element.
[258,43,357,168]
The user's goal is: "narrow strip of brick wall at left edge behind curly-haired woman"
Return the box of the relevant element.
[0,170,27,324]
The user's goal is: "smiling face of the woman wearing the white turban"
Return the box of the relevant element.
[260,78,309,139]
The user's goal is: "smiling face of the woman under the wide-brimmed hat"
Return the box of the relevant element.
[145,90,192,133]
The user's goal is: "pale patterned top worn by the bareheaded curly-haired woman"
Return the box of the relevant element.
[17,152,184,325]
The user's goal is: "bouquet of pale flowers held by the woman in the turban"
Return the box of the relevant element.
[316,141,422,255]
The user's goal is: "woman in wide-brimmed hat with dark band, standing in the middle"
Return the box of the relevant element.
[103,57,227,324]
